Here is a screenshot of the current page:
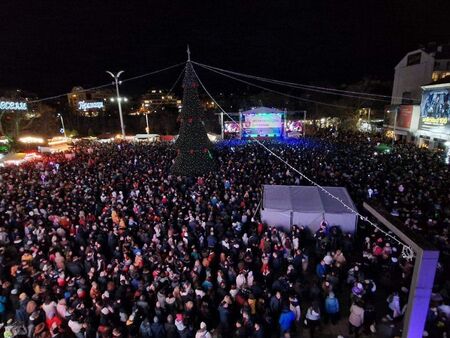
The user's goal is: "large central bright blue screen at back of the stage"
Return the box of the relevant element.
[242,113,284,137]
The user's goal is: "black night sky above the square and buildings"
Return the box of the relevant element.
[0,0,450,96]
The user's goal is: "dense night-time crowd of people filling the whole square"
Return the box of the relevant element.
[0,133,450,338]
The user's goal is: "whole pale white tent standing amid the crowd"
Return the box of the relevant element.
[261,185,358,233]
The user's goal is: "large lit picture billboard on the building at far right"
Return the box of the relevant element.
[420,86,450,134]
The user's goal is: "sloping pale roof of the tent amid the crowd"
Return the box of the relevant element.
[263,185,355,214]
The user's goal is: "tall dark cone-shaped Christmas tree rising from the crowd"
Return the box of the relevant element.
[172,56,214,176]
